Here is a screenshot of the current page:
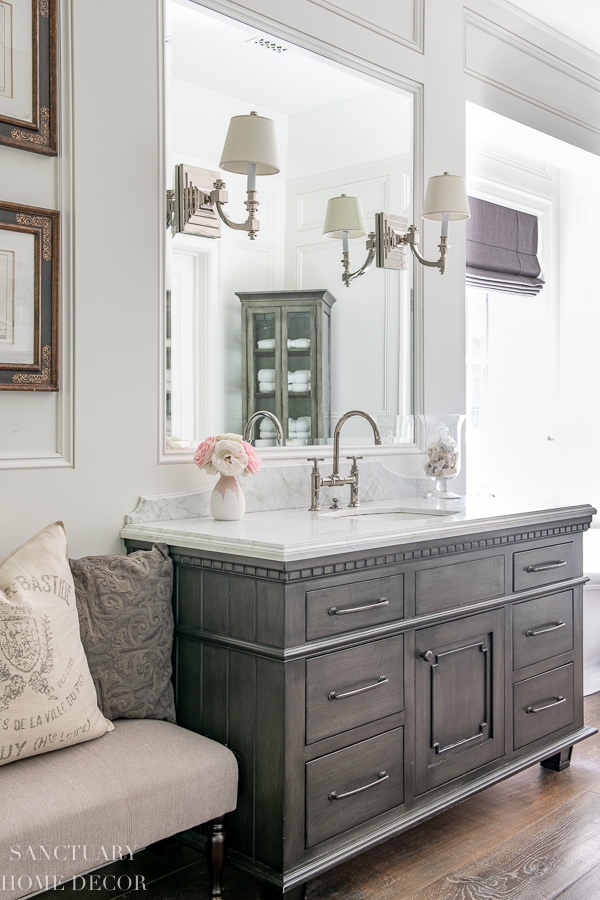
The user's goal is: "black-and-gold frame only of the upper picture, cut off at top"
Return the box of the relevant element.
[0,0,58,156]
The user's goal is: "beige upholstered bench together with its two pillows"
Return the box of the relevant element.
[0,522,238,900]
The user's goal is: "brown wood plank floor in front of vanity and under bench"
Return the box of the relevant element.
[43,693,600,900]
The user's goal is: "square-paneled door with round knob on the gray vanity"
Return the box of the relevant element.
[415,610,504,794]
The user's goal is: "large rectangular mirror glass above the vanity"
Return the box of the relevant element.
[165,0,413,455]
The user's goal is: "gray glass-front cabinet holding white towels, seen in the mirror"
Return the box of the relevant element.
[237,290,335,444]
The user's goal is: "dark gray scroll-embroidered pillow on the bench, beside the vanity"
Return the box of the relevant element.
[69,544,175,722]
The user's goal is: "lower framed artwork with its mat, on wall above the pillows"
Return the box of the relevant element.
[0,201,60,391]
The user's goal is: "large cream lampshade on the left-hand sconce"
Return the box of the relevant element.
[219,112,279,175]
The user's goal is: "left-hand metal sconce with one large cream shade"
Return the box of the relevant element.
[167,112,279,241]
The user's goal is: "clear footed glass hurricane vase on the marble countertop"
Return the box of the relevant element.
[419,413,465,500]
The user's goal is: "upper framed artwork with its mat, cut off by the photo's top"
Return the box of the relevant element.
[0,0,58,156]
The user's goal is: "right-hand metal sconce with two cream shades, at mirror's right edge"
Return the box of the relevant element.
[323,172,471,287]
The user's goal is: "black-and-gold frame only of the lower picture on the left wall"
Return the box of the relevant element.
[0,201,60,391]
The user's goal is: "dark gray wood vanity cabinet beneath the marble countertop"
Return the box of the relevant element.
[127,508,594,898]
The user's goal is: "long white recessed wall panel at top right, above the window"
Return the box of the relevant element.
[464,8,600,134]
